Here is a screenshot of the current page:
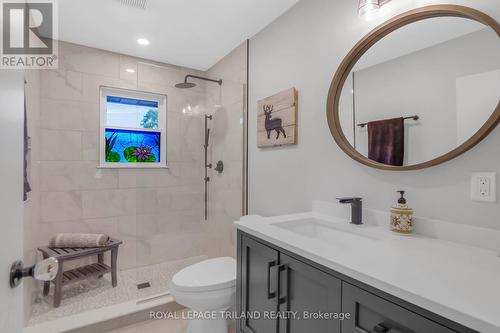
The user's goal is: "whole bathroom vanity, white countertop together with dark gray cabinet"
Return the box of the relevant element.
[236,200,500,333]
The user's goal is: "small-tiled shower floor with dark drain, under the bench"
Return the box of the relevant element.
[28,256,207,326]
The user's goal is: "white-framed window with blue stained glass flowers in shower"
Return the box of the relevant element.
[100,87,166,168]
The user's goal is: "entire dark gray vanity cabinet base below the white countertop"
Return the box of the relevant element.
[237,231,478,333]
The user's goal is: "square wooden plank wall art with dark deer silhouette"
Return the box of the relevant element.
[257,88,298,148]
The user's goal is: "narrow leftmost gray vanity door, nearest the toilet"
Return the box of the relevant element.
[238,236,279,333]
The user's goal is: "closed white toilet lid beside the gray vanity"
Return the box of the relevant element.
[172,258,236,292]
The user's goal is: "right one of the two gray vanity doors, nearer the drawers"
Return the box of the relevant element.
[278,254,342,333]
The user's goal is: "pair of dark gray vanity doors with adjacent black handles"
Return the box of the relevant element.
[238,233,342,333]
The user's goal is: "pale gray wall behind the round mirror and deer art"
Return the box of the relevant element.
[249,0,500,229]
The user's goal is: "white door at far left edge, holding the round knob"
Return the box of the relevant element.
[0,69,24,333]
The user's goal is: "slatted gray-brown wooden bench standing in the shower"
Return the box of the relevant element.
[38,239,122,308]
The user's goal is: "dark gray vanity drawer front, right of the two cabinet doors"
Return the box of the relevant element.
[342,282,455,333]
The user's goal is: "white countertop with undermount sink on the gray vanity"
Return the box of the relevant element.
[236,212,500,333]
